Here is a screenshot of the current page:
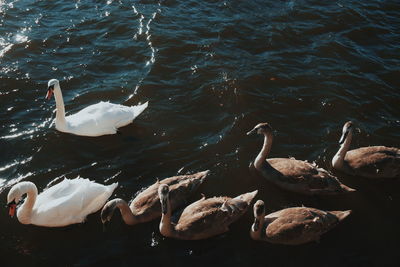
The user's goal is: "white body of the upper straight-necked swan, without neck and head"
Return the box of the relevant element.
[65,102,148,136]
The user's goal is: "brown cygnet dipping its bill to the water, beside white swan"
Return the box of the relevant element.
[101,170,209,225]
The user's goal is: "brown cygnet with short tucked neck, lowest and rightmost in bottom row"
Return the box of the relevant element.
[250,200,351,245]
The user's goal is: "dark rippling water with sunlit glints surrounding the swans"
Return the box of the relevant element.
[0,0,400,266]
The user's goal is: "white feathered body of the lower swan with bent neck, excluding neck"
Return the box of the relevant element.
[31,178,118,227]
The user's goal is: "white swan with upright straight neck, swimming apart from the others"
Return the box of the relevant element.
[46,79,148,136]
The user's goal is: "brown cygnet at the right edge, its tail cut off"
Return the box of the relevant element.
[332,121,400,178]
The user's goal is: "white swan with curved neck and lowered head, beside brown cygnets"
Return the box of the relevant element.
[7,178,118,227]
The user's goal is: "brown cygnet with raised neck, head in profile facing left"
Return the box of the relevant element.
[247,123,355,195]
